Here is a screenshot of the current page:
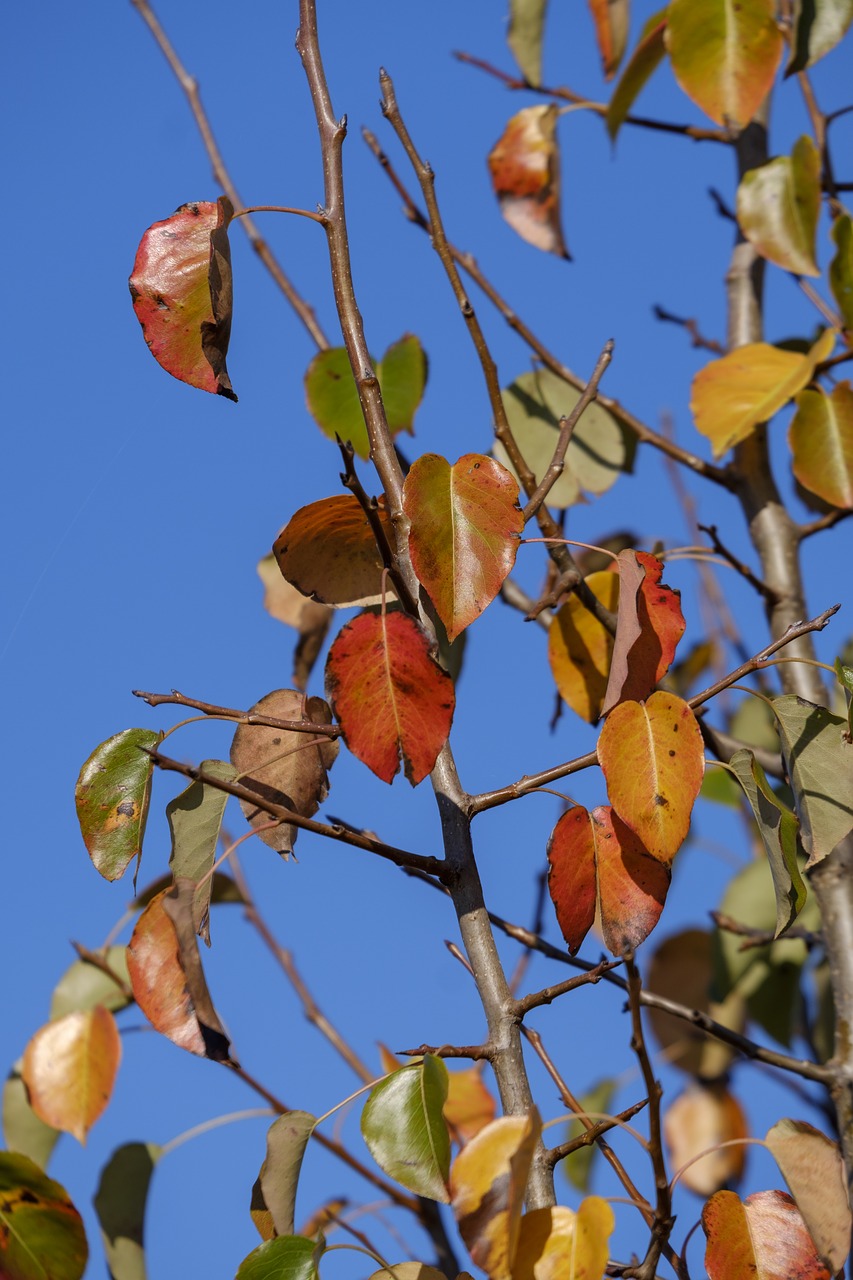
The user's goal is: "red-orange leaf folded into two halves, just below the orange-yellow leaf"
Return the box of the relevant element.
[548,805,670,956]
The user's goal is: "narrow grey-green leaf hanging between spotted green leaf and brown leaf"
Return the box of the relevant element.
[167,760,237,946]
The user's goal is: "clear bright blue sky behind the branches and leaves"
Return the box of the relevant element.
[0,0,850,1280]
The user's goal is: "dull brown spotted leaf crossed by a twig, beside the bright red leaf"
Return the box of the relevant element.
[231,689,341,855]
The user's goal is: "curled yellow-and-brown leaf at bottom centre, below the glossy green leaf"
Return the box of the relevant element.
[451,1110,542,1280]
